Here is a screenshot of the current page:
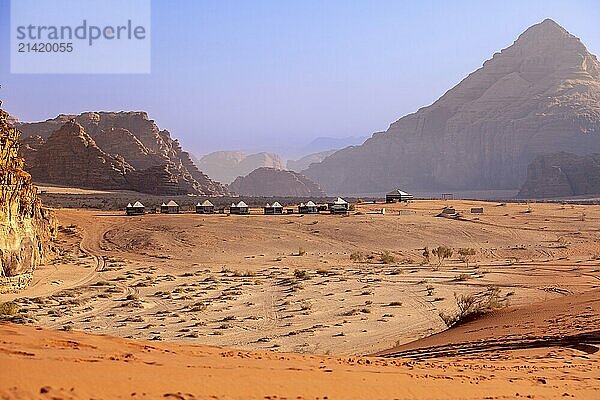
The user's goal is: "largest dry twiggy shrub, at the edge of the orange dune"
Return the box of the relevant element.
[439,288,506,328]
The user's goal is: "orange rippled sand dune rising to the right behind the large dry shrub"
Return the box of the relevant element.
[376,289,600,358]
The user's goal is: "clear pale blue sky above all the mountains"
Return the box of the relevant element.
[0,0,600,155]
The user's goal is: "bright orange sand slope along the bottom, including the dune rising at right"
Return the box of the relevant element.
[0,290,600,399]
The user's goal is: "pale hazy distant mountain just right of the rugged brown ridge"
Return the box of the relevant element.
[198,151,285,183]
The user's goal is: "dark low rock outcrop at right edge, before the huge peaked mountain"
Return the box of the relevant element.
[518,152,600,199]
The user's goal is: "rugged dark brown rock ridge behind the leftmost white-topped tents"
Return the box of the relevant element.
[15,112,226,195]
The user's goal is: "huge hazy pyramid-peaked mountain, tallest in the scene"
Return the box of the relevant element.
[304,20,600,193]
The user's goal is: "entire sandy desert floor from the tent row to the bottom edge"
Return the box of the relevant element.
[0,201,600,399]
